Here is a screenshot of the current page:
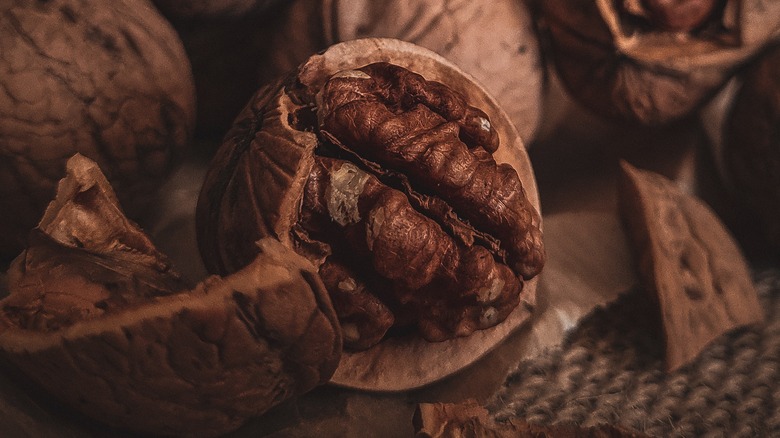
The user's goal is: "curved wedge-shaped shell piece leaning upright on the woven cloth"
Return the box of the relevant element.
[619,162,763,371]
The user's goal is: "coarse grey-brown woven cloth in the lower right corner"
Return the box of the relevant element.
[488,269,780,437]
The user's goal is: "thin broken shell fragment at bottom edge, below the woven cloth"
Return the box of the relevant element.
[413,400,646,438]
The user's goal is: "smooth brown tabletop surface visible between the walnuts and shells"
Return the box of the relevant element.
[0,65,724,437]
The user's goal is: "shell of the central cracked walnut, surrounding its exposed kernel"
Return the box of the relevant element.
[197,38,541,390]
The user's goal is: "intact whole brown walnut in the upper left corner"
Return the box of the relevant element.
[0,0,195,260]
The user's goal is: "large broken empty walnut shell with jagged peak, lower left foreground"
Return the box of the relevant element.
[0,155,341,436]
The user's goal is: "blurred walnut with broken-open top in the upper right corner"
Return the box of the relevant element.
[535,0,780,125]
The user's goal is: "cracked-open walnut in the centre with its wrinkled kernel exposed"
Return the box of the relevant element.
[197,39,545,390]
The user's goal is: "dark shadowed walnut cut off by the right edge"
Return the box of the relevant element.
[702,45,780,256]
